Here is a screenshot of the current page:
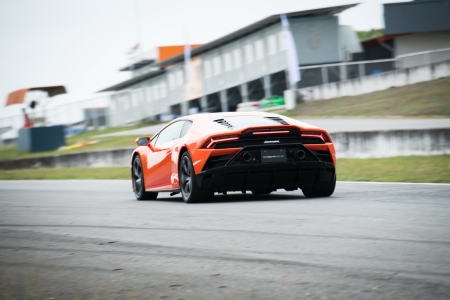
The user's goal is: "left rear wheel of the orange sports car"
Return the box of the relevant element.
[178,152,214,203]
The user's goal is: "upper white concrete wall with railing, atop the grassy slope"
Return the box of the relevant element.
[298,61,450,101]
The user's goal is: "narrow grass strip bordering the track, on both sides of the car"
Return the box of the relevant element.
[0,155,450,183]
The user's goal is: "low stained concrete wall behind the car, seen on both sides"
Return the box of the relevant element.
[0,128,450,170]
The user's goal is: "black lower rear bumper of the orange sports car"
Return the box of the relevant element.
[196,161,336,192]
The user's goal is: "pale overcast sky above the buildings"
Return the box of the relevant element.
[0,0,412,108]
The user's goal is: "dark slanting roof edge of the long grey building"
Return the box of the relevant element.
[154,3,359,67]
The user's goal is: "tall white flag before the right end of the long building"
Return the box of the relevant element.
[280,14,301,88]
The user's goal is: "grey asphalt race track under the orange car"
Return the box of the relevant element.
[0,181,450,299]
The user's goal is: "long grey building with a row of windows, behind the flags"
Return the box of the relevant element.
[103,4,362,126]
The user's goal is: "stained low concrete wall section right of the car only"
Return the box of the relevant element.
[331,129,450,159]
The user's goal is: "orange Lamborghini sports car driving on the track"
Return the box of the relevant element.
[131,112,336,203]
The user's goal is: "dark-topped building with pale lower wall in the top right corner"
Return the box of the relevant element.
[362,0,450,68]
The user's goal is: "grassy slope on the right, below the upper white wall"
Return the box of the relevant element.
[286,77,450,117]
